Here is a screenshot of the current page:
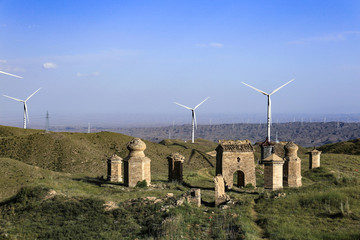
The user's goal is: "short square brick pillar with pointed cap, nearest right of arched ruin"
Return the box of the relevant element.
[263,154,284,190]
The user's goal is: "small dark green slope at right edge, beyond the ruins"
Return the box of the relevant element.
[319,138,360,155]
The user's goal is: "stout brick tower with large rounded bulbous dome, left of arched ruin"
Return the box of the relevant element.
[124,138,151,187]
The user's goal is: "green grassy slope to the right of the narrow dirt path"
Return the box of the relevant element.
[255,154,360,239]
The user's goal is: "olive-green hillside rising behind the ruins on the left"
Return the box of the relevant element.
[0,126,216,177]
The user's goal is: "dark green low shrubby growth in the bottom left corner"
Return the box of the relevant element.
[0,187,169,239]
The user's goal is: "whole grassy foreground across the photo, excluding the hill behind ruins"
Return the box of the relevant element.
[0,154,360,239]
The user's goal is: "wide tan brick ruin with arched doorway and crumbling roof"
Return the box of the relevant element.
[216,140,256,188]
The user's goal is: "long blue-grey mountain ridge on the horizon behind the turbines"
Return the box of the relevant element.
[107,122,360,147]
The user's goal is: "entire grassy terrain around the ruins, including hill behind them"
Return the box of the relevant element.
[0,125,360,239]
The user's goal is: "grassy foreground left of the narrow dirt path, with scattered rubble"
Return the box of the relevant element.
[0,155,259,239]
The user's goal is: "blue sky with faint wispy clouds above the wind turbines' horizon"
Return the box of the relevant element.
[0,0,360,126]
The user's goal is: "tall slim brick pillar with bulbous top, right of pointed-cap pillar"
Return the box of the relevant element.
[283,141,302,187]
